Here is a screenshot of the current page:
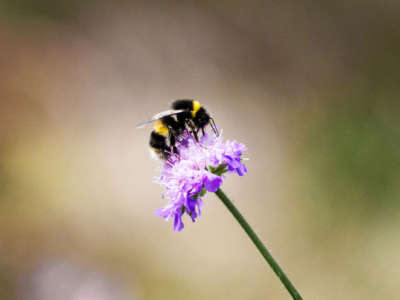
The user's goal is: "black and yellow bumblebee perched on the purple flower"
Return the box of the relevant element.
[137,99,218,160]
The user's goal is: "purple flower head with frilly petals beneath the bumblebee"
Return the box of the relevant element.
[155,132,247,231]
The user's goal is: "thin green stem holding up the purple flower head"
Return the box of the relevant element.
[215,189,303,300]
